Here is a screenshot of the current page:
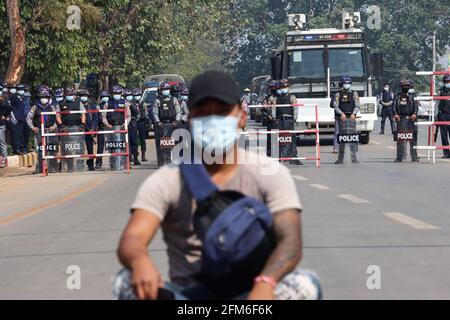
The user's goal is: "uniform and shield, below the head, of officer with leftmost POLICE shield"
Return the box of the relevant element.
[27,99,58,173]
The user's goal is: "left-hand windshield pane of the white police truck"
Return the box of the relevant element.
[288,49,325,79]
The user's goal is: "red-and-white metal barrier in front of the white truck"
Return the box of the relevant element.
[240,103,321,168]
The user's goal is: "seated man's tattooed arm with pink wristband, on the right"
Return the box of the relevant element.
[249,210,303,300]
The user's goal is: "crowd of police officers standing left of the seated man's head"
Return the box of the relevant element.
[0,82,189,173]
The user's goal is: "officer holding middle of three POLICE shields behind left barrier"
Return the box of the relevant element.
[56,87,86,172]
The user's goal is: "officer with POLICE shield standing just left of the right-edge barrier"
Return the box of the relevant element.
[394,80,419,162]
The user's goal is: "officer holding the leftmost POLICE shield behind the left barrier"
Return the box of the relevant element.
[27,85,58,174]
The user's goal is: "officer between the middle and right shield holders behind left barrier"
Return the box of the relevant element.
[78,89,99,171]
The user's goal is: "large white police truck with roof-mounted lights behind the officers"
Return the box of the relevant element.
[271,12,383,144]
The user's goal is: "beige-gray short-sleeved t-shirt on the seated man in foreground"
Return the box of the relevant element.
[131,152,302,285]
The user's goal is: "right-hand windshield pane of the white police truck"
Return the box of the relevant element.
[328,48,364,77]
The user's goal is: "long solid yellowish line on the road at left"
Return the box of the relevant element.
[0,178,106,226]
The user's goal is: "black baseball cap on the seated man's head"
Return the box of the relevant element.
[188,71,241,109]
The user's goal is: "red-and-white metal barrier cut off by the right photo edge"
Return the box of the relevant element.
[414,68,450,164]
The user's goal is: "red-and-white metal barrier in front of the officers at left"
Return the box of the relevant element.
[41,109,131,177]
